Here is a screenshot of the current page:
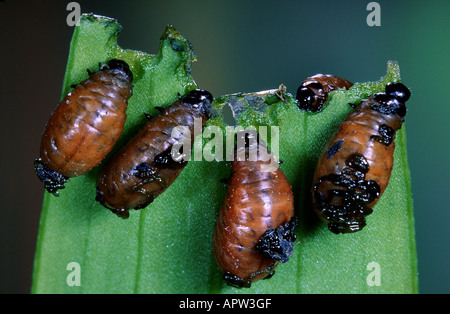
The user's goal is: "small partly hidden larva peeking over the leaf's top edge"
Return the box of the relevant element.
[296,74,353,112]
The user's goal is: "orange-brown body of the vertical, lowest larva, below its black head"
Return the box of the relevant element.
[214,135,295,287]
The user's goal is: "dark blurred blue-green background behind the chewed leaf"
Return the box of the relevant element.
[0,0,450,293]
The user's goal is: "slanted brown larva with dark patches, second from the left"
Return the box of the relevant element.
[96,90,213,218]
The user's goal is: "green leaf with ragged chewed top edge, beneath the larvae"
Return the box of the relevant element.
[32,15,417,293]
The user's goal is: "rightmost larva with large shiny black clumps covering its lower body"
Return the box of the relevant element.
[313,83,410,233]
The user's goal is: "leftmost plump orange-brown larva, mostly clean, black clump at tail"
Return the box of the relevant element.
[35,59,133,194]
